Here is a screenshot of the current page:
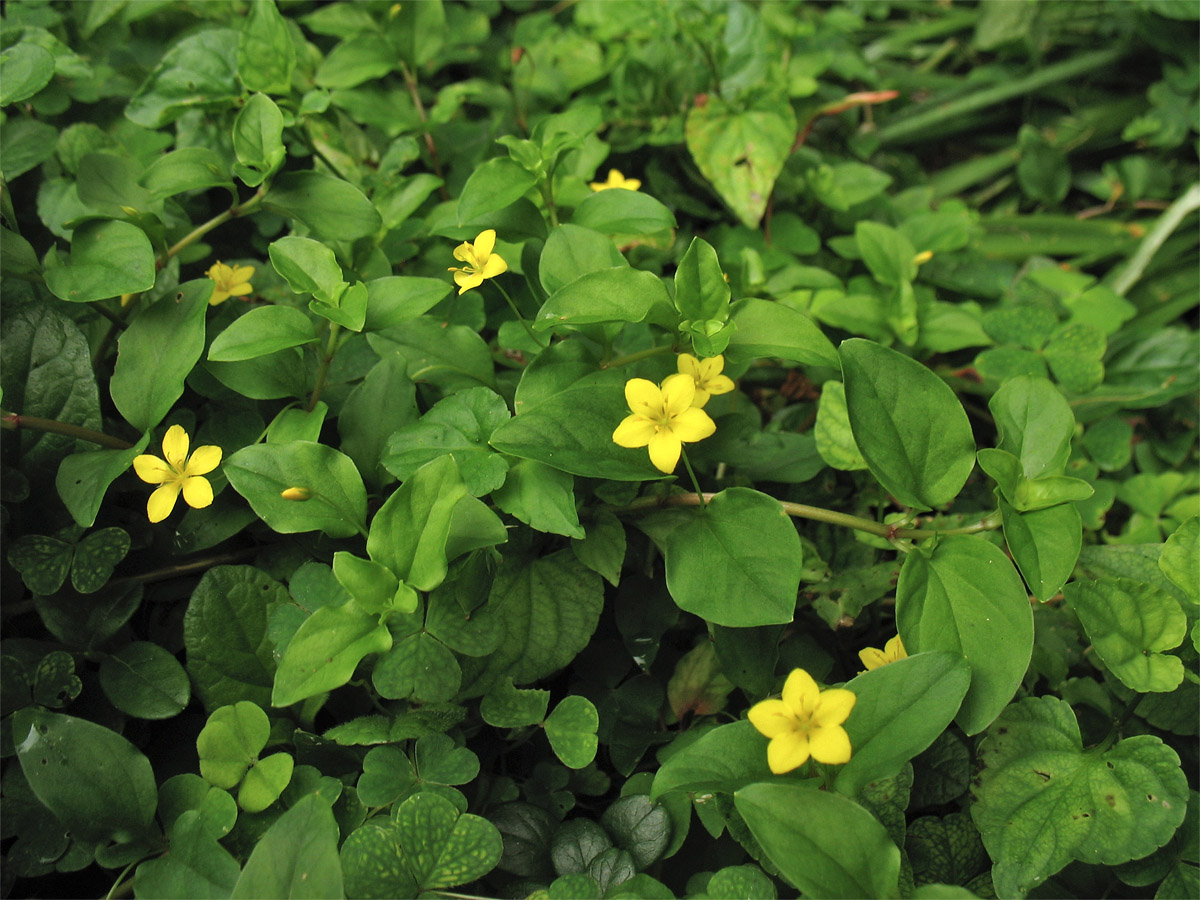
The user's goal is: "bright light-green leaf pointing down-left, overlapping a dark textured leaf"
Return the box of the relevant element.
[271,604,392,707]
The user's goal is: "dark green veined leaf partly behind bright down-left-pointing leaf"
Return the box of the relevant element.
[184,565,289,709]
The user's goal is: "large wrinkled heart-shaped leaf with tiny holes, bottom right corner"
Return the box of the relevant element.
[971,697,1188,896]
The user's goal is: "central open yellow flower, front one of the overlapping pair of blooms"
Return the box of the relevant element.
[612,374,716,475]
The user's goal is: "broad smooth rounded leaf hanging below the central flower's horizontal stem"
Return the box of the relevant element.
[662,487,803,628]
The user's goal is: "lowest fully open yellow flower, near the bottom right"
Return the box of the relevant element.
[749,668,858,775]
